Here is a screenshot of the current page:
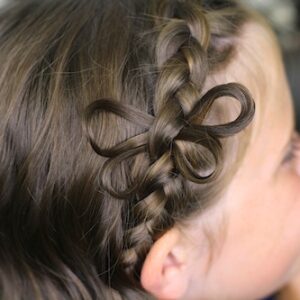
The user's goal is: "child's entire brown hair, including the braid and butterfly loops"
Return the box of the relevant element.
[0,0,255,300]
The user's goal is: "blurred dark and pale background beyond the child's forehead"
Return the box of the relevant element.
[0,0,300,130]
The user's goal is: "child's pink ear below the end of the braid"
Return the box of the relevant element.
[141,227,190,299]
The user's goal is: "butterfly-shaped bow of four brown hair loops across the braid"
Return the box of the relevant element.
[84,83,255,199]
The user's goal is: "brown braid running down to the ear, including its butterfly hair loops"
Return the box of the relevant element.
[84,1,255,290]
